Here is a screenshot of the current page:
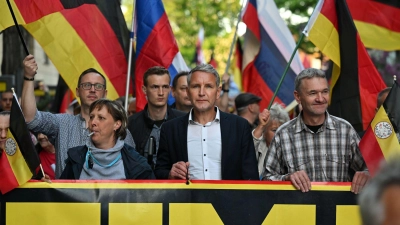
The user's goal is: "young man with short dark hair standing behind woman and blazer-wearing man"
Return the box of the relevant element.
[128,66,185,166]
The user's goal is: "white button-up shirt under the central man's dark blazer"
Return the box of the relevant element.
[187,107,222,180]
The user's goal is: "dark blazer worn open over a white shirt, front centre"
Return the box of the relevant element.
[154,111,259,180]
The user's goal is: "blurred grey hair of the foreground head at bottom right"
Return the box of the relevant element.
[358,158,400,225]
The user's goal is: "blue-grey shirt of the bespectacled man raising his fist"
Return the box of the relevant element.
[27,110,135,178]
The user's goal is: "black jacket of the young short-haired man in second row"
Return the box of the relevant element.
[128,104,186,155]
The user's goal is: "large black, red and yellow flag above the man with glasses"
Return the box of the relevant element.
[0,0,132,99]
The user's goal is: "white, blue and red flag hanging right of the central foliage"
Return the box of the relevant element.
[243,0,304,109]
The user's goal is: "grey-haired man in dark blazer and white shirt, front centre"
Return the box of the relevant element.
[155,65,259,180]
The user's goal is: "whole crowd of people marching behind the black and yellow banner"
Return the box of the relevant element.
[0,55,396,207]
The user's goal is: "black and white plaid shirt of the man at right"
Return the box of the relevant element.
[263,112,367,182]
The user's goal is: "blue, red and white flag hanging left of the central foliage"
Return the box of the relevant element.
[135,0,189,111]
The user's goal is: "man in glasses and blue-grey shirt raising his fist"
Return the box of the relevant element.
[21,55,135,178]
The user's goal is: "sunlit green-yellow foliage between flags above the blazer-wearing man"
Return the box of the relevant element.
[164,0,241,70]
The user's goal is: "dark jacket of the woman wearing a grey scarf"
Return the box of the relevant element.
[60,144,155,180]
